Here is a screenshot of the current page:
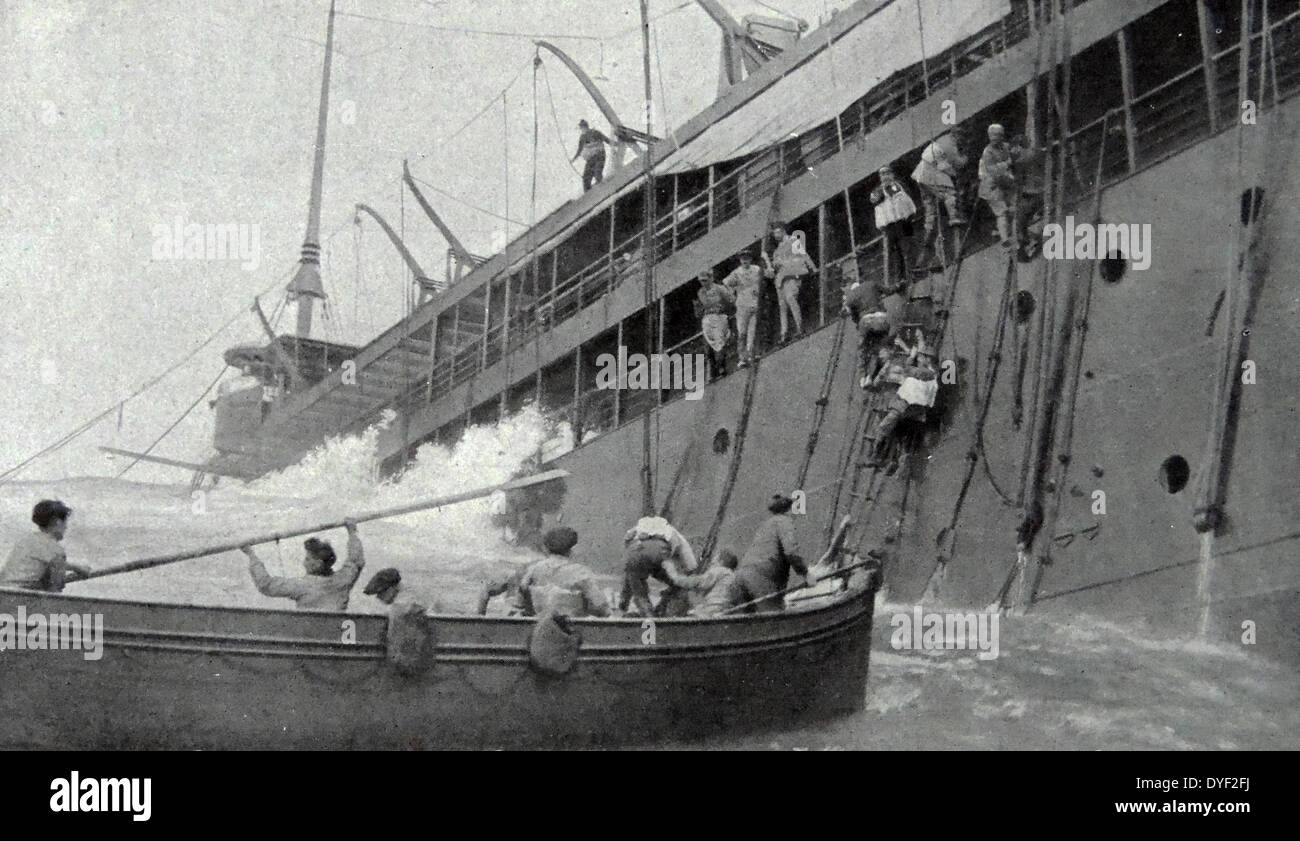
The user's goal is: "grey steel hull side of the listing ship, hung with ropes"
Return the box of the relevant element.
[540,100,1300,666]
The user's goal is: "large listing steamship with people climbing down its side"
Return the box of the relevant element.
[195,0,1300,663]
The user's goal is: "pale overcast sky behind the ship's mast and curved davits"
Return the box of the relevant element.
[0,0,850,482]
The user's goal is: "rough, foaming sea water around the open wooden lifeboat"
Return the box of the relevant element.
[0,411,1300,750]
